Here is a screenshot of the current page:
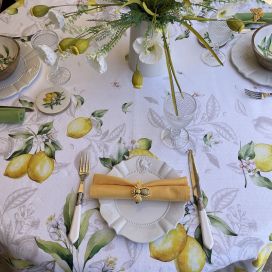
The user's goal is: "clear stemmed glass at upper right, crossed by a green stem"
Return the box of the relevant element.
[201,21,232,67]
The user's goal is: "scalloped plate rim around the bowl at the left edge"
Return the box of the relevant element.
[0,44,41,100]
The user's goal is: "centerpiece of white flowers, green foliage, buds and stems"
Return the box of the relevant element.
[31,0,251,115]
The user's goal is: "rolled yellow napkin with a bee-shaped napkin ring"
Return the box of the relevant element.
[90,174,190,203]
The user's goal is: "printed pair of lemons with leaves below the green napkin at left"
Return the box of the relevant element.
[4,122,62,183]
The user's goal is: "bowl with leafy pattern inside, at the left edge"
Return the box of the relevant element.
[0,35,20,80]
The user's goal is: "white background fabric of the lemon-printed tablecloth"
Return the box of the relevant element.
[0,1,272,272]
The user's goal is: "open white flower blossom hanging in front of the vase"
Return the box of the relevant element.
[133,34,163,64]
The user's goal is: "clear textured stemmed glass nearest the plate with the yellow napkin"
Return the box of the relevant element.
[161,92,197,149]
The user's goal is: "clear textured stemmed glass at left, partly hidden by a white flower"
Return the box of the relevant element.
[31,30,71,85]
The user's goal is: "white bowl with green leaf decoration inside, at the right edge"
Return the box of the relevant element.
[251,24,272,71]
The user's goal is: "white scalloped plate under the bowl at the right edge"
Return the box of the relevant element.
[231,31,272,87]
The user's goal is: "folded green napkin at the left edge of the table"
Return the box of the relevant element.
[0,106,25,124]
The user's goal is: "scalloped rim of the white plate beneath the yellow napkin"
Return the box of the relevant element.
[98,156,185,243]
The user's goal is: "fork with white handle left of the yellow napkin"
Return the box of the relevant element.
[68,154,90,244]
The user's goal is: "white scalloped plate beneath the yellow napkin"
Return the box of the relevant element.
[99,156,185,243]
